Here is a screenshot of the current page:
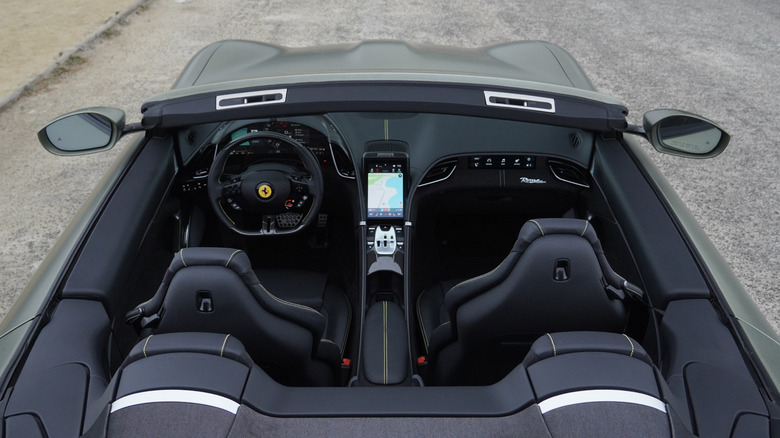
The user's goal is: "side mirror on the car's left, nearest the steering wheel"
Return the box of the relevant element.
[38,107,125,155]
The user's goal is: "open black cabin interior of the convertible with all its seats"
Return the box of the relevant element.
[4,42,777,437]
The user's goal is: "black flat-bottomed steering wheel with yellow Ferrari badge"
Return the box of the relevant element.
[208,131,323,236]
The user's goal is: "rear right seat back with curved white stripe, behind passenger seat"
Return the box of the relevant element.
[522,332,688,437]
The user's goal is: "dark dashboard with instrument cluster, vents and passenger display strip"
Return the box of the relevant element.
[180,113,593,222]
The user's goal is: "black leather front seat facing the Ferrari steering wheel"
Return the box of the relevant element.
[128,248,351,386]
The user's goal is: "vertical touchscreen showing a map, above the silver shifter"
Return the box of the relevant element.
[367,166,404,218]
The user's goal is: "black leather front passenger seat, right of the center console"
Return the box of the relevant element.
[417,218,641,385]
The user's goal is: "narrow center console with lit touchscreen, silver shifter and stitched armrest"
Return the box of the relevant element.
[357,145,413,386]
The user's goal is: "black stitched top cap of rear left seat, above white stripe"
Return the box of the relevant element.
[123,332,254,367]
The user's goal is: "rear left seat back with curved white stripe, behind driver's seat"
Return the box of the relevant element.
[82,332,258,438]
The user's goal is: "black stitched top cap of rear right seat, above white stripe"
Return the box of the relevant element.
[523,331,653,367]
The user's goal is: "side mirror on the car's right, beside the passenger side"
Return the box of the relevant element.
[643,110,731,158]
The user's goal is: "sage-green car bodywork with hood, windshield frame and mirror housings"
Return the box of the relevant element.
[0,41,780,434]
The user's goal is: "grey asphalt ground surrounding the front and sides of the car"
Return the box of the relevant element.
[0,0,780,336]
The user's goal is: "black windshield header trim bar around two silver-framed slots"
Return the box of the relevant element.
[141,81,628,132]
